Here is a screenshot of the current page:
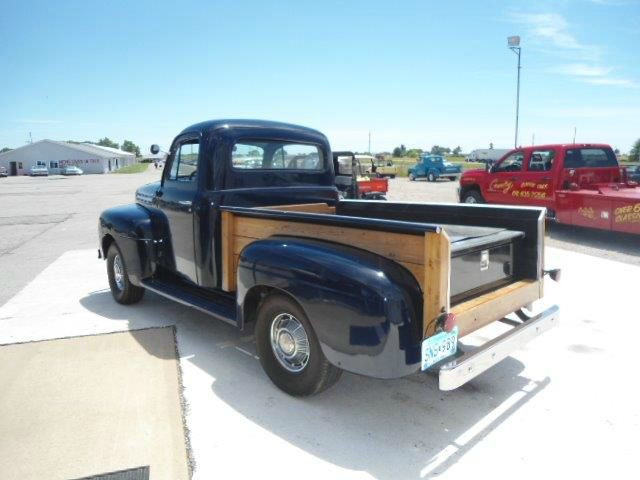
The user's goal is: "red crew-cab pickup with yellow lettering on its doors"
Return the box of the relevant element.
[459,144,640,235]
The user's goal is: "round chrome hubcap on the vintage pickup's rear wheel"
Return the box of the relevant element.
[271,313,309,373]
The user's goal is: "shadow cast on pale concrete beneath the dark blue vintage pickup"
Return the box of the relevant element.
[80,291,550,479]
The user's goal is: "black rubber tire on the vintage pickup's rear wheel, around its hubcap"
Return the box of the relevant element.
[255,294,342,397]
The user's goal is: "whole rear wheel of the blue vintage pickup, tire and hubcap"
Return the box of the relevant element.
[255,294,342,397]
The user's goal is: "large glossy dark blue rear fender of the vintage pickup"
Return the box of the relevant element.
[237,236,422,378]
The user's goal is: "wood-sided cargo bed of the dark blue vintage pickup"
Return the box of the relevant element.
[222,201,542,337]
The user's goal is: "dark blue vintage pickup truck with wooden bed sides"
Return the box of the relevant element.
[99,120,559,396]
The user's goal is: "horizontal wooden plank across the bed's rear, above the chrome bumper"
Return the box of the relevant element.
[451,280,542,337]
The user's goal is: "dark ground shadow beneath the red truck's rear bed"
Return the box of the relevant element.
[547,223,640,258]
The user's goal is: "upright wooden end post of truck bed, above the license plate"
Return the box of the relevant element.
[422,230,451,338]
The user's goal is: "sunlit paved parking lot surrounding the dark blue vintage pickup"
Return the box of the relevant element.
[0,170,640,479]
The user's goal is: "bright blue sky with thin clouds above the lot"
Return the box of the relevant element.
[0,0,640,151]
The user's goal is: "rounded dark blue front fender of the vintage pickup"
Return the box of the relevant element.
[98,204,163,285]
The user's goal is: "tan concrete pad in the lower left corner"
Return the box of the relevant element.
[0,328,189,480]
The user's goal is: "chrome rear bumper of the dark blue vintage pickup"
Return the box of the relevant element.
[439,305,560,391]
